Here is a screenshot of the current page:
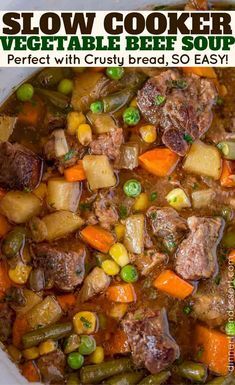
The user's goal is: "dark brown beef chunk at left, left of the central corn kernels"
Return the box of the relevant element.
[32,240,85,291]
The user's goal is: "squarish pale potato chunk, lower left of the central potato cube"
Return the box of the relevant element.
[47,178,81,212]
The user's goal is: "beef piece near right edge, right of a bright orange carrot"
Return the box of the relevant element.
[191,270,229,327]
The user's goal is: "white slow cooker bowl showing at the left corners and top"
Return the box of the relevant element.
[0,0,231,385]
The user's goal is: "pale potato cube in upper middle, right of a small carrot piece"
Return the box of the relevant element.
[83,155,116,190]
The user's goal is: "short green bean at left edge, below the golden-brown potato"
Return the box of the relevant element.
[2,227,26,258]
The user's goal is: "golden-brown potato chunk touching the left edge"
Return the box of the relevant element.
[0,191,41,223]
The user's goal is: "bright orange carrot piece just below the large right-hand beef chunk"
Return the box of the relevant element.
[153,270,194,299]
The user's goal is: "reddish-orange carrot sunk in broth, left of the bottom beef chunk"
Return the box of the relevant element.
[104,329,130,356]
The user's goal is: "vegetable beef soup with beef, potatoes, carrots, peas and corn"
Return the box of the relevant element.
[0,4,235,385]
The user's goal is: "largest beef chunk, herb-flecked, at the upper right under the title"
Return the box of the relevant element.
[137,70,217,156]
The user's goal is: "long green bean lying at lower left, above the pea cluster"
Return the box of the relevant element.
[22,322,73,349]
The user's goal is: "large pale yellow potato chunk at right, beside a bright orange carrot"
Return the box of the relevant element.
[183,140,222,180]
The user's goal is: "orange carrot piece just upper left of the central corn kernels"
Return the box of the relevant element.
[81,226,115,253]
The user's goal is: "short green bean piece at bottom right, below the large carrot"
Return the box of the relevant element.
[175,361,207,382]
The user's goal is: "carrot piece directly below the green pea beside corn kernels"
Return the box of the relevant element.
[106,283,136,303]
